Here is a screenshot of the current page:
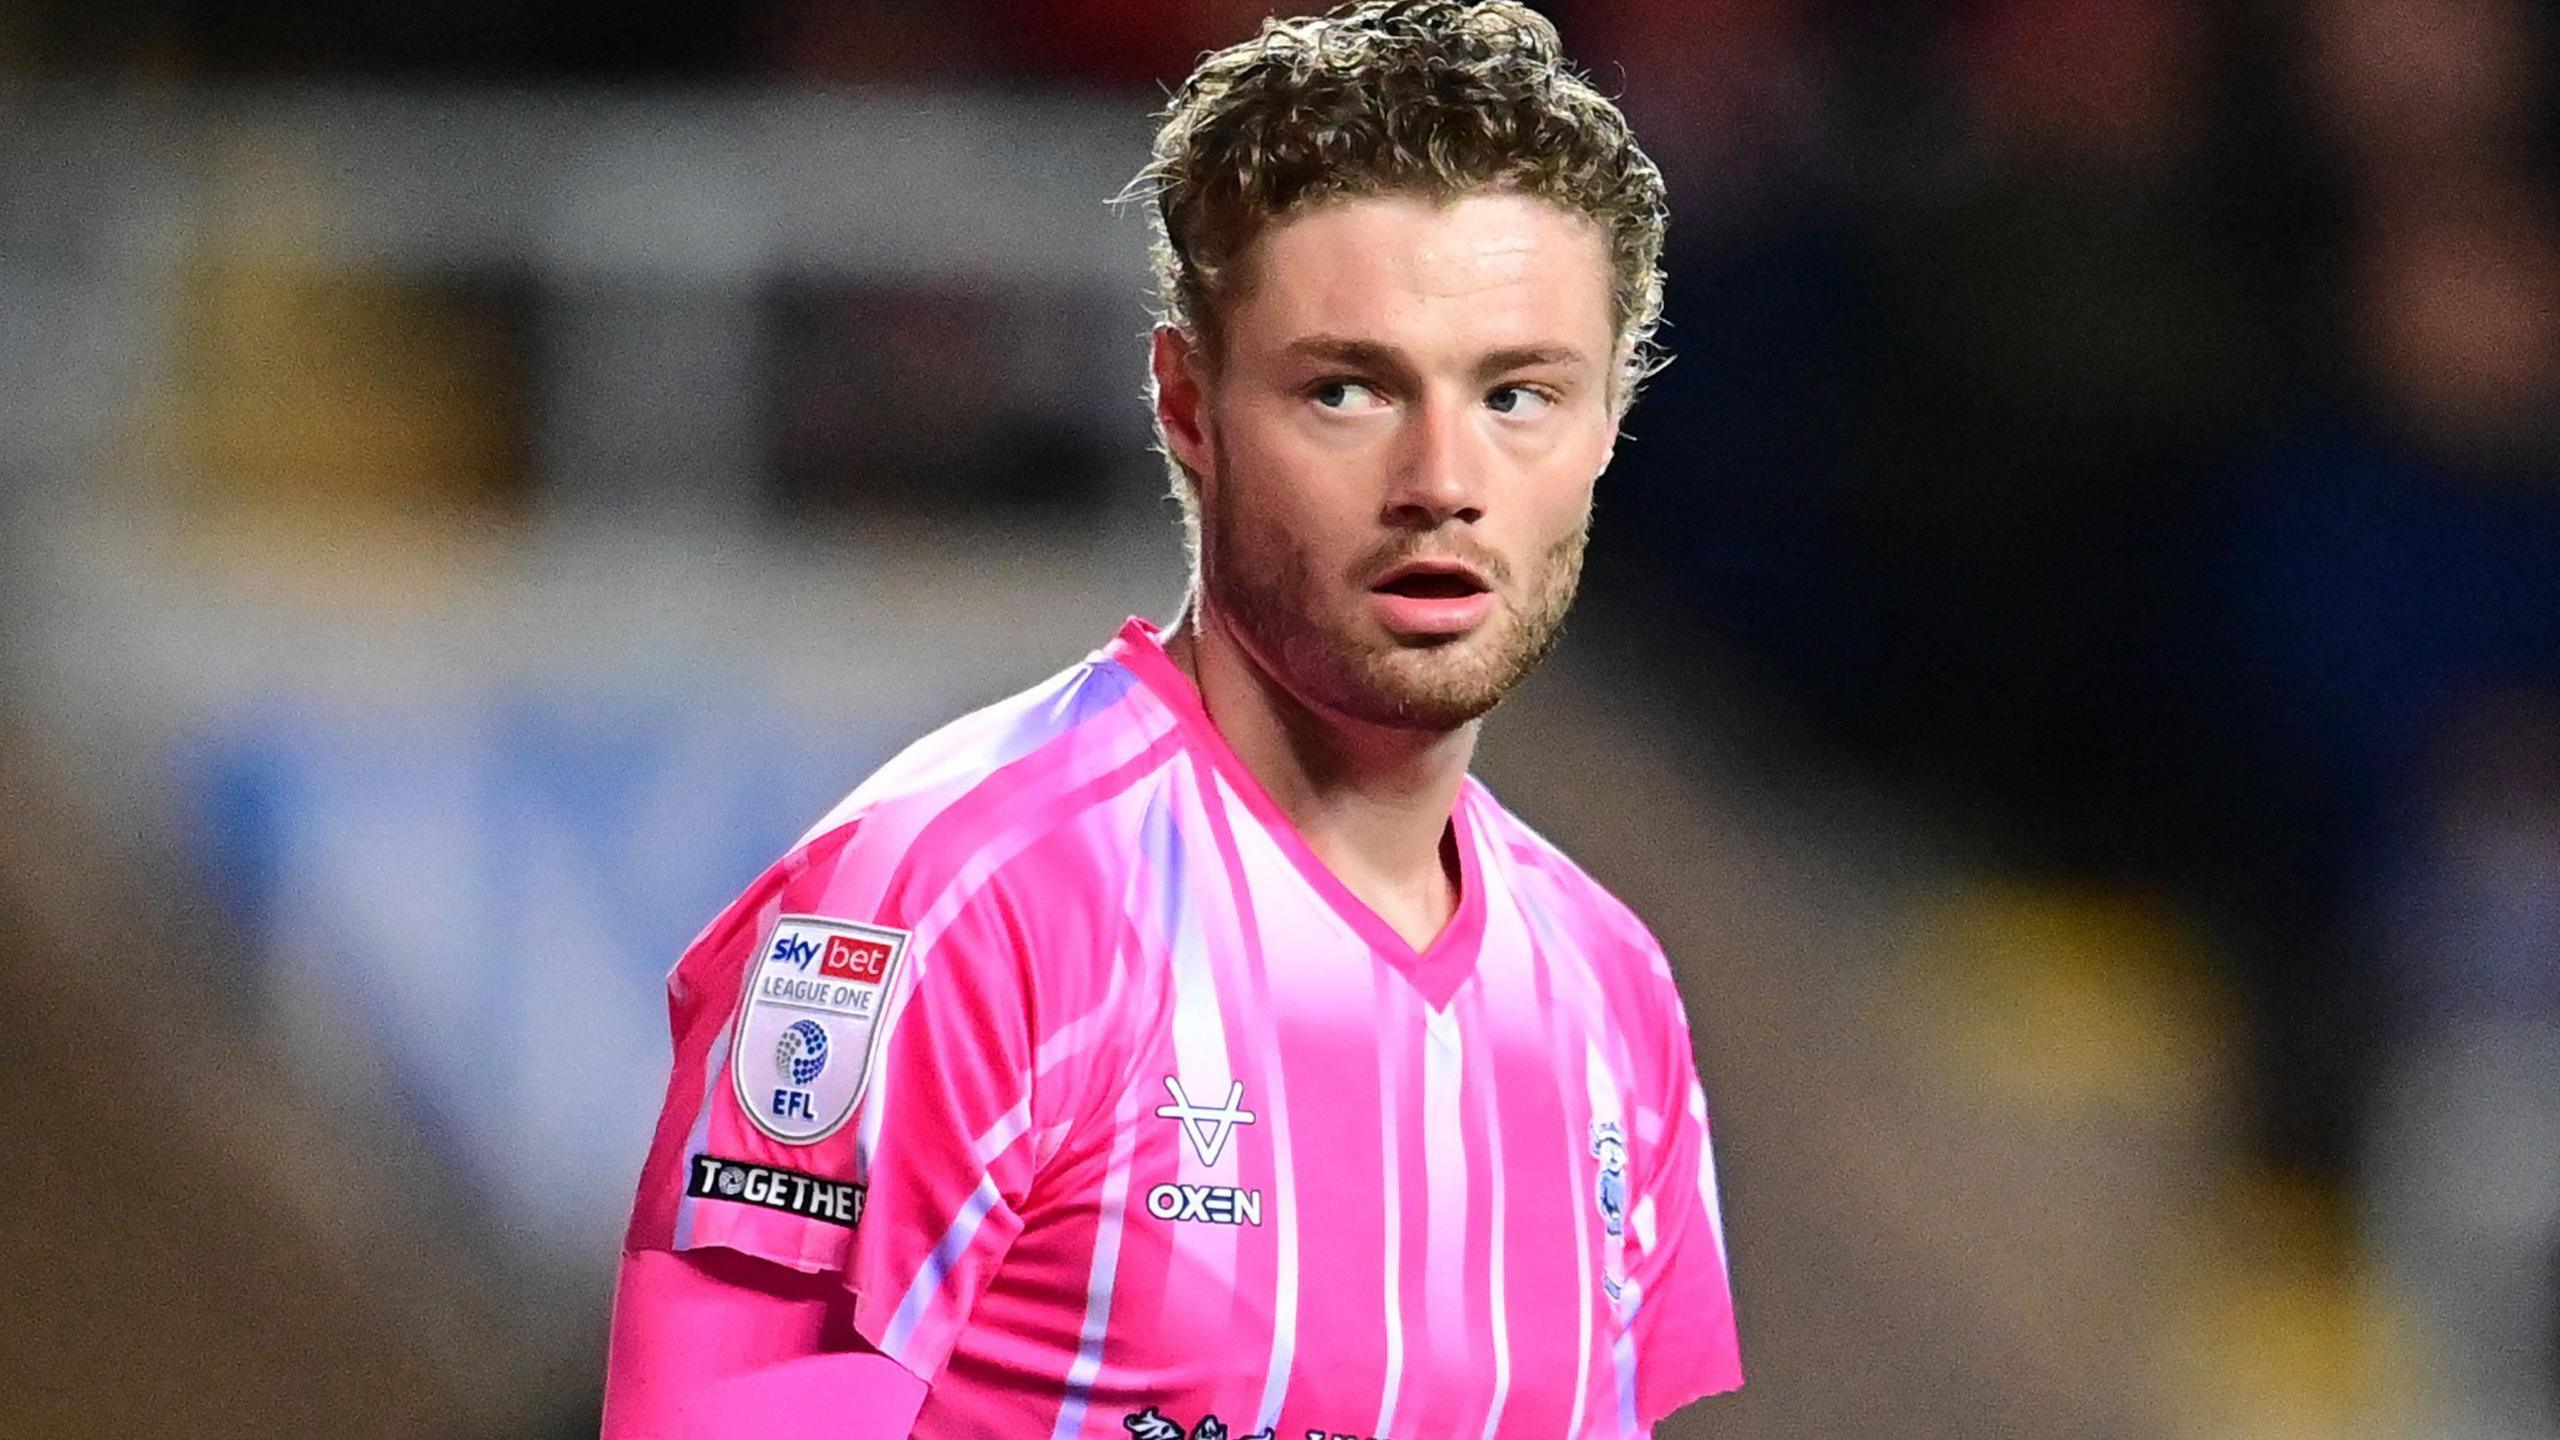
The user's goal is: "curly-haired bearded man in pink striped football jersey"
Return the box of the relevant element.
[604,0,1741,1440]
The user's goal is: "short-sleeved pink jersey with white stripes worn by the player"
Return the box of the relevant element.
[630,609,1741,1440]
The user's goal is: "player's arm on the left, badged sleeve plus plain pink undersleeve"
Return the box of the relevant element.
[604,828,1034,1414]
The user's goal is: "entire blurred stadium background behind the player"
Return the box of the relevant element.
[0,0,2560,1440]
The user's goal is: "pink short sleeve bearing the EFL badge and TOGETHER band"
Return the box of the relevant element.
[627,828,1037,1381]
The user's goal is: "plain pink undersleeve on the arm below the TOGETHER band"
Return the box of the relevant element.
[604,1250,924,1440]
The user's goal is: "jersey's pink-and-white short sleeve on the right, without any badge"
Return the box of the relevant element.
[1628,953,1743,1425]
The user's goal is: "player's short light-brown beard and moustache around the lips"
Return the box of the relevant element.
[1201,466,1590,730]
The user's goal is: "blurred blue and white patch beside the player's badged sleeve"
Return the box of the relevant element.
[179,682,886,1250]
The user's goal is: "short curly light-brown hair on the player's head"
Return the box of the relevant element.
[1124,0,1667,413]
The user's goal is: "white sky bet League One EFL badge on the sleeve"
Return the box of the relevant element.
[730,915,906,1145]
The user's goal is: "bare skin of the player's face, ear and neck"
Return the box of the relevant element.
[1155,192,1618,948]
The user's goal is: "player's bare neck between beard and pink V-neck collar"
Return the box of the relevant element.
[1165,605,1477,951]
